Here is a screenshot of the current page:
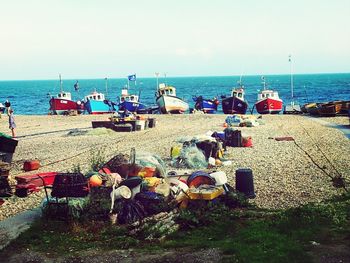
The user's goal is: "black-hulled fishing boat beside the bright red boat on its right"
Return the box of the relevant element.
[221,77,248,114]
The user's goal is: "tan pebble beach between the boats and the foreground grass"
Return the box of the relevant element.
[0,114,350,220]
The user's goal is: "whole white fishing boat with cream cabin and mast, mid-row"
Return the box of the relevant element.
[155,73,189,114]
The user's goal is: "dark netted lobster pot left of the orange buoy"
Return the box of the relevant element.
[51,173,89,198]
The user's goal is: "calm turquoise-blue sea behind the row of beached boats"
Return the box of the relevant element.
[0,74,350,115]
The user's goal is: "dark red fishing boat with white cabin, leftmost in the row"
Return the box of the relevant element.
[49,74,84,115]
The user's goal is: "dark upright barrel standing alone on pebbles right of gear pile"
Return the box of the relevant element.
[236,168,256,198]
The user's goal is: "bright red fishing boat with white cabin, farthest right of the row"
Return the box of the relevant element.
[255,77,283,114]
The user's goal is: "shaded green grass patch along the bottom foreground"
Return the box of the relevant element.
[1,194,350,262]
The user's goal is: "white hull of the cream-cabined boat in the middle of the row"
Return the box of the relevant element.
[156,95,189,114]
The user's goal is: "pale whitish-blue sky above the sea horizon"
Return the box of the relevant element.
[0,0,350,80]
